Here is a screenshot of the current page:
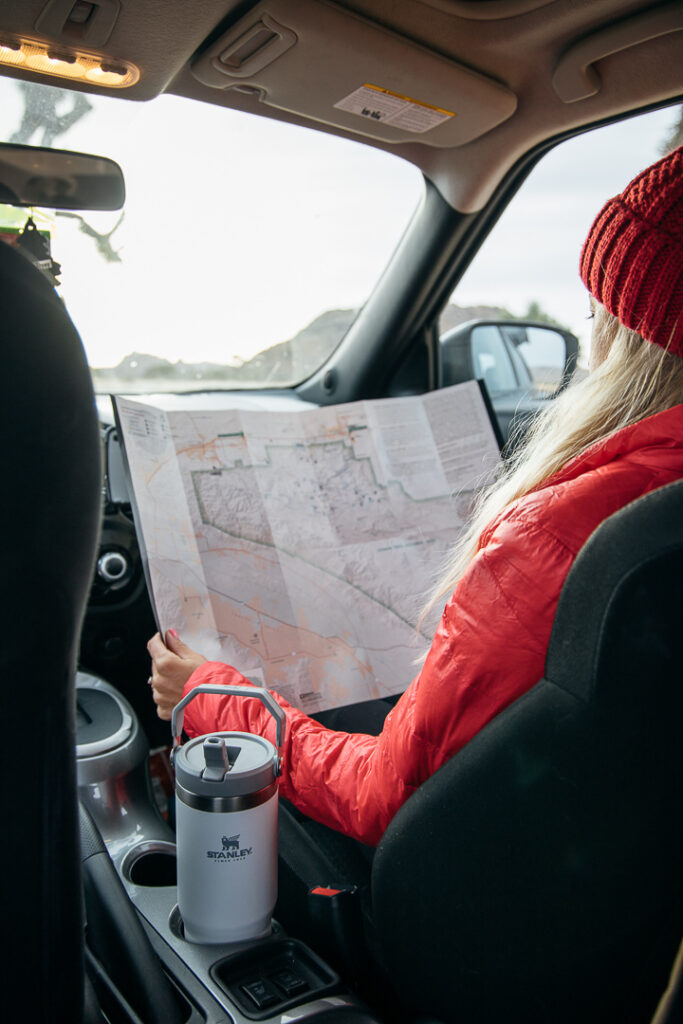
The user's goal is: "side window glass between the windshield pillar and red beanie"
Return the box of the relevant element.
[440,106,683,368]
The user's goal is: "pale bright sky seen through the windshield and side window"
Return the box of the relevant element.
[0,79,676,367]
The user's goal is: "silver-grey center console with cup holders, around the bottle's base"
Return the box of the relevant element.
[76,673,379,1024]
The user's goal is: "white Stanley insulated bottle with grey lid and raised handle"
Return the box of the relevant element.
[172,686,287,943]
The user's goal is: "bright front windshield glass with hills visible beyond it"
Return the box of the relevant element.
[0,79,423,393]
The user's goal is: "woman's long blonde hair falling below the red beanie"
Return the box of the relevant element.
[420,303,683,623]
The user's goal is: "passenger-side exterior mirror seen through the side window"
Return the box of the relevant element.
[439,321,579,399]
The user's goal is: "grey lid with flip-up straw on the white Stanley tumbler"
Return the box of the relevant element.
[175,732,278,797]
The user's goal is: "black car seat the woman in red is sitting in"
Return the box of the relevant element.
[372,481,683,1024]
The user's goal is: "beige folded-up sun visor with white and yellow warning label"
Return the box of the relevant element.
[191,0,517,147]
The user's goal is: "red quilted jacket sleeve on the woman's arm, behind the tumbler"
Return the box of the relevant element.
[180,515,573,845]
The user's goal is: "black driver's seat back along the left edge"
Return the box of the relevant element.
[0,234,101,1022]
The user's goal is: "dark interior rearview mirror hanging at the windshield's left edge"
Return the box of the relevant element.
[0,142,126,210]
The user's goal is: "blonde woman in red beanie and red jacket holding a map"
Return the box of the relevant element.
[148,148,683,845]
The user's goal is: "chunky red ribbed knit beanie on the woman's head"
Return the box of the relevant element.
[581,146,683,356]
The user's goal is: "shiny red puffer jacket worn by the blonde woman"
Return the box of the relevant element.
[184,406,683,845]
